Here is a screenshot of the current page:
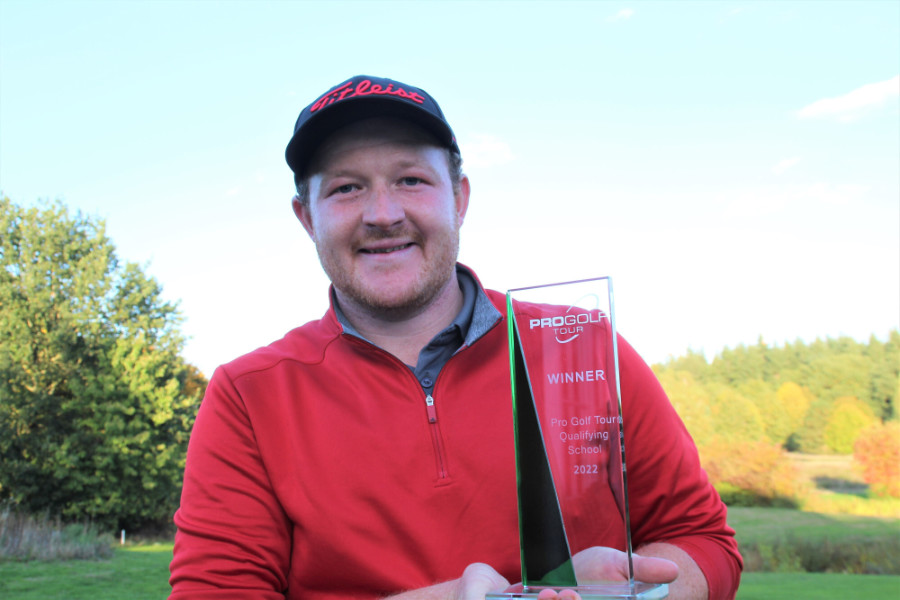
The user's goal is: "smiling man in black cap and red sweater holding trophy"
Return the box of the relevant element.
[171,76,741,600]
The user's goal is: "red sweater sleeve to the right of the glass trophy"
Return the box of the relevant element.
[619,337,743,600]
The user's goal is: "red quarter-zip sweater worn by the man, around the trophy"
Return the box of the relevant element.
[170,284,741,600]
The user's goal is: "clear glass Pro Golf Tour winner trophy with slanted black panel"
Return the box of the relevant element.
[487,277,668,600]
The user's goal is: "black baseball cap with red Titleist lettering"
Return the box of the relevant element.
[284,75,459,179]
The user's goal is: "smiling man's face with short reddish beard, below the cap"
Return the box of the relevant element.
[294,119,469,319]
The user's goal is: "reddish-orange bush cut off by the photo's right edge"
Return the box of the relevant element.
[853,421,900,498]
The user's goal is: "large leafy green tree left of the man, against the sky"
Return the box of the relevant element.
[0,198,205,528]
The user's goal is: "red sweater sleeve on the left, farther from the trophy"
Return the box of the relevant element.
[169,368,291,600]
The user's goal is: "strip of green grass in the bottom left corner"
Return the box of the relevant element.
[0,544,172,600]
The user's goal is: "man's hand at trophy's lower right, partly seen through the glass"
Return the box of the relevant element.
[572,546,678,584]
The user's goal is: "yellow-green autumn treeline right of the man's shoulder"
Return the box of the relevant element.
[653,330,900,499]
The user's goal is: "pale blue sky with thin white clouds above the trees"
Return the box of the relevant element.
[0,0,900,376]
